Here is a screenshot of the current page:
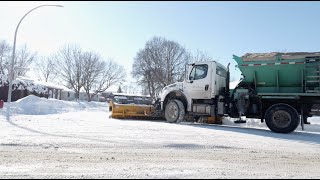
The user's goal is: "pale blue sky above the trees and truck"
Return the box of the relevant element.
[0,1,320,86]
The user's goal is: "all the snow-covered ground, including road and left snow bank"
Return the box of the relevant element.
[0,96,320,179]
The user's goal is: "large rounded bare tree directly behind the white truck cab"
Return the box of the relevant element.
[132,37,190,98]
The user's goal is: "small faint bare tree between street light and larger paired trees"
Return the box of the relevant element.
[34,57,58,82]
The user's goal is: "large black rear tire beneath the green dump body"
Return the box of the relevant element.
[265,103,300,133]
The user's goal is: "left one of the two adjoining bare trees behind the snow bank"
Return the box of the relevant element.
[55,45,84,100]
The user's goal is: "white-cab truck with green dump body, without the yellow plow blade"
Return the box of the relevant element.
[155,52,320,133]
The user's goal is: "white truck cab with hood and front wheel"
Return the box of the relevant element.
[160,61,227,122]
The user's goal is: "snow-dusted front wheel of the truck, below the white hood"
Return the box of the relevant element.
[164,99,185,123]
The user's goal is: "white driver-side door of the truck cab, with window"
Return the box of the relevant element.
[184,63,212,99]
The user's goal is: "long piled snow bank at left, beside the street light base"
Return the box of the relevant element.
[0,95,108,115]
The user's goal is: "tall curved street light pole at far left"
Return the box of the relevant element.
[6,5,63,120]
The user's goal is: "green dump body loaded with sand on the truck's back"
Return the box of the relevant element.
[233,52,320,94]
